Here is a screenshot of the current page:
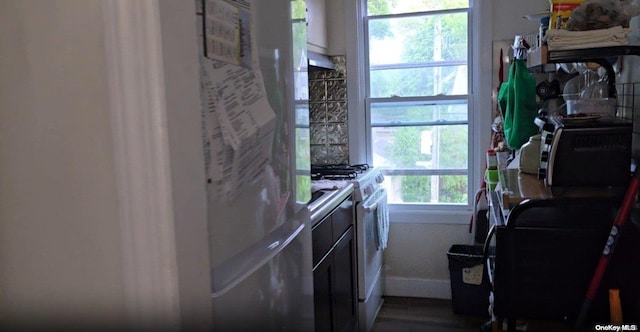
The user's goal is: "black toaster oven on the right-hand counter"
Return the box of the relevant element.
[538,116,632,187]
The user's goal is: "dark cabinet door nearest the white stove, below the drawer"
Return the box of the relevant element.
[331,227,358,332]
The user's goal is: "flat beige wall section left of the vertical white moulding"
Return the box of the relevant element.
[0,0,124,330]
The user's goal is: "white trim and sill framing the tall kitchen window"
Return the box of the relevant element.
[344,0,495,224]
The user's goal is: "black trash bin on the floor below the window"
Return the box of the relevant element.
[447,244,493,317]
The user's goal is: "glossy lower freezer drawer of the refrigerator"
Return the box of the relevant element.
[213,219,314,331]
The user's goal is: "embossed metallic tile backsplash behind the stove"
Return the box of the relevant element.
[309,57,349,164]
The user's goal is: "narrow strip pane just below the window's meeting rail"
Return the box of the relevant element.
[371,100,468,126]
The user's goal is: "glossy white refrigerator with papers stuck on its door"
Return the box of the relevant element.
[196,0,313,331]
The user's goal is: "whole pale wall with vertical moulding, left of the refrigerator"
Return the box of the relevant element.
[0,0,211,331]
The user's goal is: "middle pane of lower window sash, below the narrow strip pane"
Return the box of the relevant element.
[371,125,468,170]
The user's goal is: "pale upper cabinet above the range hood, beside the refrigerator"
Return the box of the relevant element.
[307,0,345,55]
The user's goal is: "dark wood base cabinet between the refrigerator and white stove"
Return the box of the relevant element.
[312,197,358,332]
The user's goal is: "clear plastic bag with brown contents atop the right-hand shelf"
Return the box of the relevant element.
[566,0,639,31]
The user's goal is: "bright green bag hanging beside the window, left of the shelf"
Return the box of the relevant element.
[498,59,538,150]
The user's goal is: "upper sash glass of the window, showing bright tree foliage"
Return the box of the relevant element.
[369,12,468,97]
